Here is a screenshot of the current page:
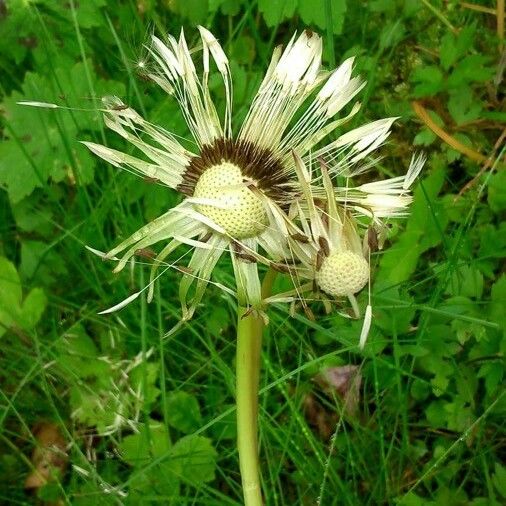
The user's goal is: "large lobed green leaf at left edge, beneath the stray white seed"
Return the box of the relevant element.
[0,61,124,203]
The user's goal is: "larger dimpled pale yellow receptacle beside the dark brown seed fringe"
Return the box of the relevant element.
[193,162,267,239]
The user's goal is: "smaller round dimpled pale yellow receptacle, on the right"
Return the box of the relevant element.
[316,251,369,297]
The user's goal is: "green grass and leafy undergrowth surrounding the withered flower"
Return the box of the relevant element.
[0,0,506,506]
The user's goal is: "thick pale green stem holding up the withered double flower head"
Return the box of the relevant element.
[236,306,263,506]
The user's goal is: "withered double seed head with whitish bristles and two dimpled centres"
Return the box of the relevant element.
[75,27,423,332]
